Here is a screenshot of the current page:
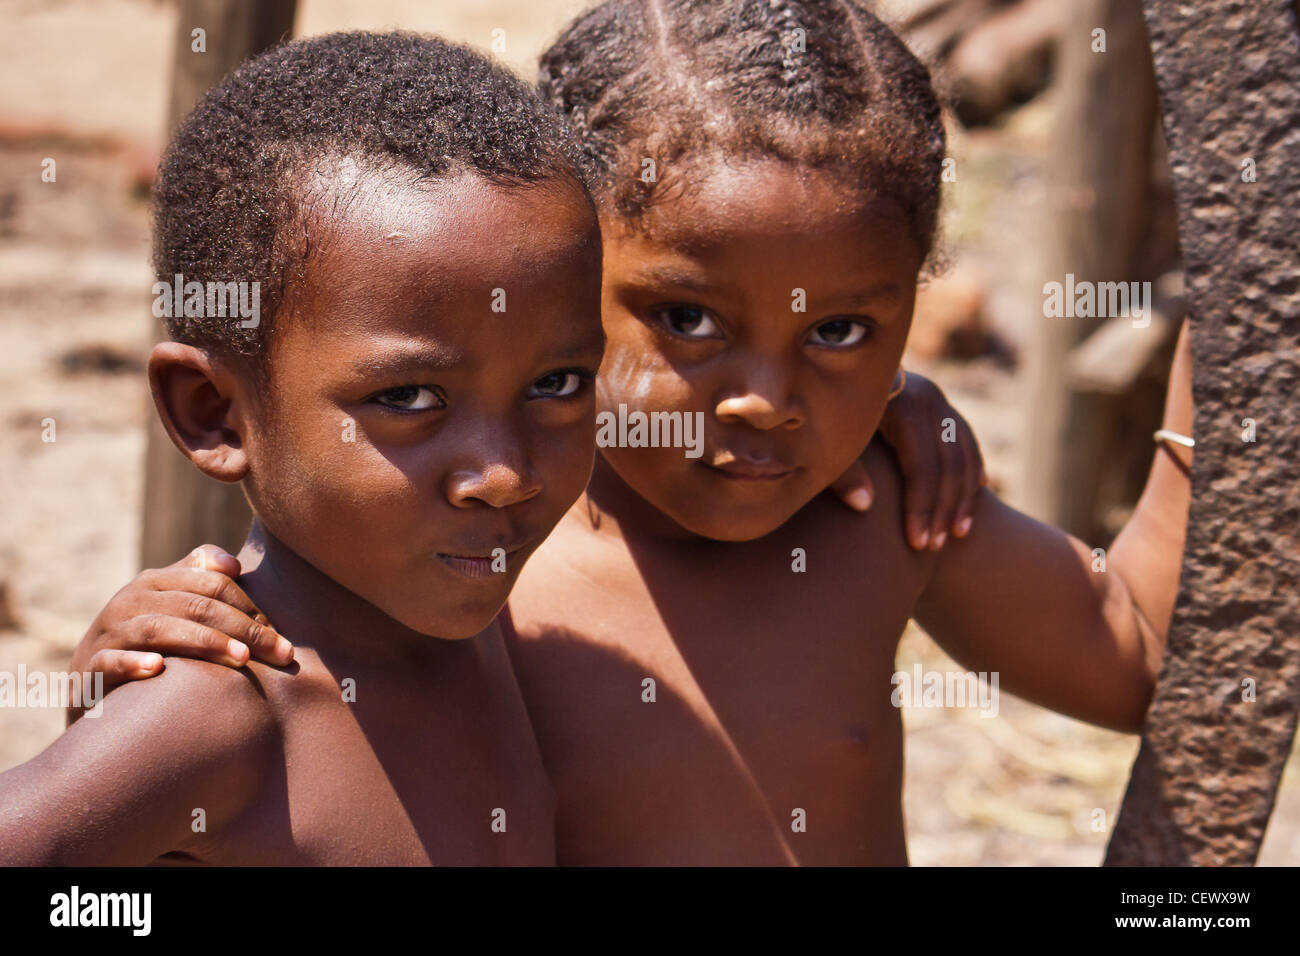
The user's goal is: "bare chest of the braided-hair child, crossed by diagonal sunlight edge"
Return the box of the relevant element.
[510,515,911,864]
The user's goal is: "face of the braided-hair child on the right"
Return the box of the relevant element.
[597,160,922,541]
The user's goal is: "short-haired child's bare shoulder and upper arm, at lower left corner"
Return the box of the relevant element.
[0,659,276,866]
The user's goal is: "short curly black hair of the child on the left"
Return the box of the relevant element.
[153,33,581,372]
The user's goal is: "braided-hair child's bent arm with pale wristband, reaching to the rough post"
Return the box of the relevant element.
[915,321,1192,732]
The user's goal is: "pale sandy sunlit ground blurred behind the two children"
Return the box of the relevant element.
[0,0,1300,866]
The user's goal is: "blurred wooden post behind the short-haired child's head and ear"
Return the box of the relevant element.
[140,0,296,567]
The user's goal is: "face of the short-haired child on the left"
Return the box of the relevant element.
[244,169,602,637]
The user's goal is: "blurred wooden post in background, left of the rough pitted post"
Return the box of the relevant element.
[1023,0,1156,541]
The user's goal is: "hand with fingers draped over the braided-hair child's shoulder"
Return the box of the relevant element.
[832,372,988,551]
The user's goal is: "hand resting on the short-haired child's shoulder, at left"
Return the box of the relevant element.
[72,545,294,712]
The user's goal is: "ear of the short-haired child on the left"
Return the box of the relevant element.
[148,342,248,483]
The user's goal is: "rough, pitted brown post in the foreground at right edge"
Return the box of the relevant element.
[1106,0,1300,865]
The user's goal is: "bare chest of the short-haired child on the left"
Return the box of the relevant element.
[201,634,554,865]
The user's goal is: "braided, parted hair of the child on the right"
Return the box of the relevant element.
[538,0,945,269]
